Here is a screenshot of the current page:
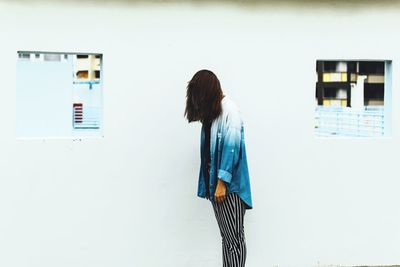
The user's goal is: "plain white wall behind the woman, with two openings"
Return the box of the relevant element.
[0,1,400,267]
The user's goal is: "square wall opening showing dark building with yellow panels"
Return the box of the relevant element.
[315,60,392,137]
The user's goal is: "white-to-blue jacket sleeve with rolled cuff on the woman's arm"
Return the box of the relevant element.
[218,110,242,183]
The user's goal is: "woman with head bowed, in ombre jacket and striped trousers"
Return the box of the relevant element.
[185,70,253,267]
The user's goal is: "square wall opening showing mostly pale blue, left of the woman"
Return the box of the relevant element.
[16,51,103,139]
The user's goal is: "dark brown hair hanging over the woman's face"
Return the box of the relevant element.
[184,70,224,123]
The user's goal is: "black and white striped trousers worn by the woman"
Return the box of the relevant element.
[211,193,246,267]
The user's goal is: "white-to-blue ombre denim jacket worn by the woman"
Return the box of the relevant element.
[197,96,253,209]
